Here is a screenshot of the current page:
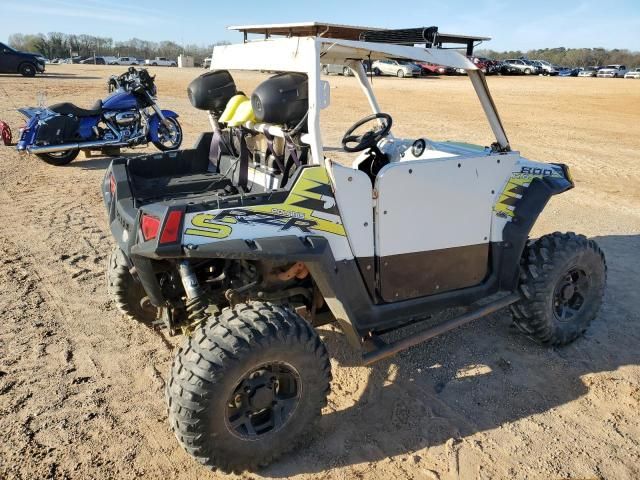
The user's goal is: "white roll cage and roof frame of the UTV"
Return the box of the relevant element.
[211,23,510,164]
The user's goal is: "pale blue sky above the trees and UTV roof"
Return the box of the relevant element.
[0,0,640,51]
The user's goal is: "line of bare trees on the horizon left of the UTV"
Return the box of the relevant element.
[9,32,228,63]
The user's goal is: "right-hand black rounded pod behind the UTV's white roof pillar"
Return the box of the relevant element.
[251,73,309,126]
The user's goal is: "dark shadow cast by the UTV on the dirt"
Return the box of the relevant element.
[261,235,640,478]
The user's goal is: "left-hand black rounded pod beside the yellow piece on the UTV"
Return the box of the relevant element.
[187,70,237,115]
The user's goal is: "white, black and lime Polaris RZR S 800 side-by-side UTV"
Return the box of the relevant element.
[103,23,606,471]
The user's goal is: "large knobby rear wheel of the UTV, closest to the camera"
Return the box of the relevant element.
[166,302,331,472]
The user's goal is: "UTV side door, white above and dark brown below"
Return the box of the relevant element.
[375,155,516,302]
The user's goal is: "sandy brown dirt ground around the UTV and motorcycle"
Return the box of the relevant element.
[0,65,640,480]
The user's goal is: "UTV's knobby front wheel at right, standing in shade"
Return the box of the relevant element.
[511,232,607,346]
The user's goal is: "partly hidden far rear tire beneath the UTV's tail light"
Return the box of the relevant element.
[107,246,157,324]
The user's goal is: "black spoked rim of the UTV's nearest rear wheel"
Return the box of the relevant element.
[226,362,302,440]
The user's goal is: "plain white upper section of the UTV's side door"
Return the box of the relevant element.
[375,152,519,257]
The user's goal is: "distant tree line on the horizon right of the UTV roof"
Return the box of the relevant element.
[476,47,640,68]
